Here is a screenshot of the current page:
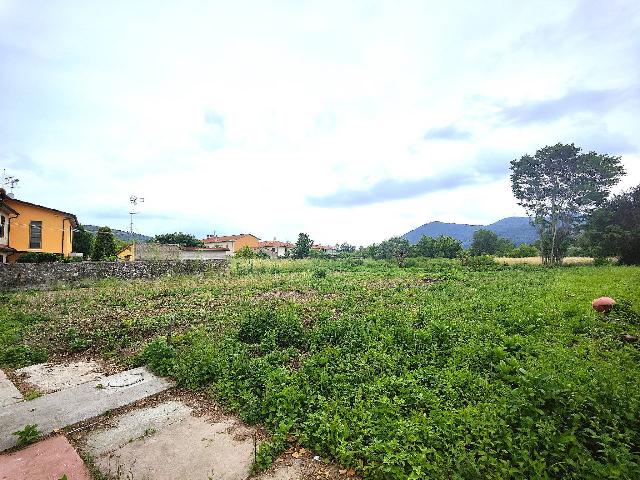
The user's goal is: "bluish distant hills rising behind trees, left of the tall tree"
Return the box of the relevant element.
[402,217,538,247]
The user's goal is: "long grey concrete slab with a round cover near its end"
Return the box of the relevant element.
[0,367,172,452]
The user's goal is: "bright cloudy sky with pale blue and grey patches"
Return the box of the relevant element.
[0,0,640,245]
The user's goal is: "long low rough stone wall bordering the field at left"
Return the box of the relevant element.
[0,260,229,290]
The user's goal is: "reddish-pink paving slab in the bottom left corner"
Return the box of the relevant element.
[0,435,91,480]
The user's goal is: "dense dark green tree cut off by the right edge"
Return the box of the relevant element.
[583,185,640,265]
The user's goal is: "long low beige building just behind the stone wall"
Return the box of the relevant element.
[116,243,229,262]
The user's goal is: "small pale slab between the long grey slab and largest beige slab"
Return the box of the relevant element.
[86,401,191,457]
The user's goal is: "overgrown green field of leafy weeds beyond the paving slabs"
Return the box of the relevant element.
[0,259,640,479]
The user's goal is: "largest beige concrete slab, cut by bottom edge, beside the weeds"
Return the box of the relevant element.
[88,416,253,480]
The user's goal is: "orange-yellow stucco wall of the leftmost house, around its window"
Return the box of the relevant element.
[4,198,73,261]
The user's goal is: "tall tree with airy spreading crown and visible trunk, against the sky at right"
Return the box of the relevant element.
[511,143,624,265]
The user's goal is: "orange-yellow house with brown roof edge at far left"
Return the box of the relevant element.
[0,188,78,263]
